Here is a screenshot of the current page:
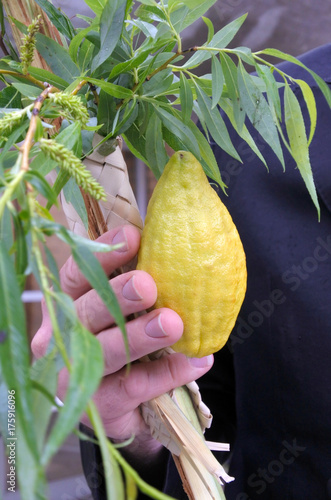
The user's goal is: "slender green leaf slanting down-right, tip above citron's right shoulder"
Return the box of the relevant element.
[196,85,241,161]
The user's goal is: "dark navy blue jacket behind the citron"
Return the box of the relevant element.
[80,44,331,500]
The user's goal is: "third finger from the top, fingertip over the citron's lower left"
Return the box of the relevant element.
[97,308,183,375]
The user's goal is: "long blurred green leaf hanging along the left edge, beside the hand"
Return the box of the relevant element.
[0,241,38,458]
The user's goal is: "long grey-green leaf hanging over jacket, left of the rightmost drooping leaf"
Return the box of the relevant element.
[238,62,285,168]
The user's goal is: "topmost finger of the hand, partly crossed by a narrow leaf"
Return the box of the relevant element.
[60,225,140,299]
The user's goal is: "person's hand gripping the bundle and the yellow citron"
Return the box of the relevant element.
[32,226,213,453]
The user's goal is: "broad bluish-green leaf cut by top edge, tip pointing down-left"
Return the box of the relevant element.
[91,0,126,71]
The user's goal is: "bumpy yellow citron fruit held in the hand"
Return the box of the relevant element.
[137,151,247,357]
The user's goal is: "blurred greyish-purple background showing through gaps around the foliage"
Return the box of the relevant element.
[0,0,331,500]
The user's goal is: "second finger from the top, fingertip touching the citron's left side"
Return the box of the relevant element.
[75,271,157,333]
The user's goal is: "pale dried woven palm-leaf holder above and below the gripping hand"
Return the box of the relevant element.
[61,134,233,500]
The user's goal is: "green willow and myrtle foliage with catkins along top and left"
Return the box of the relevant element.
[0,0,331,500]
